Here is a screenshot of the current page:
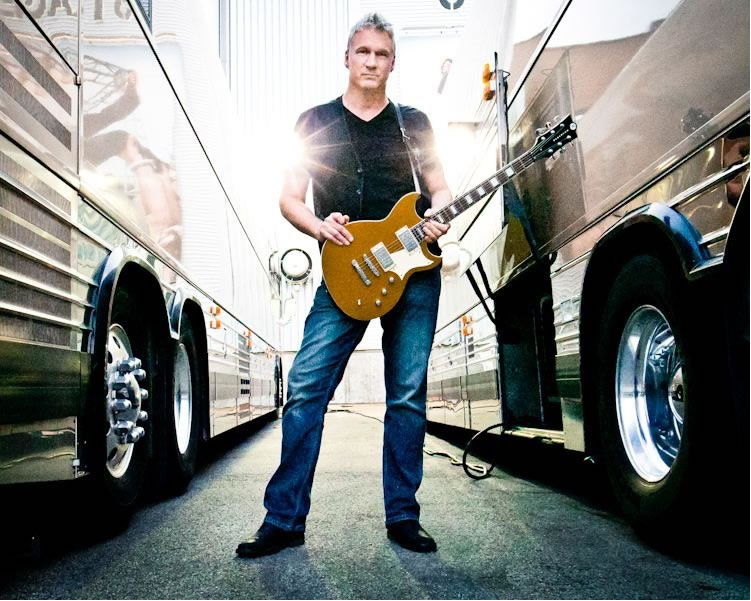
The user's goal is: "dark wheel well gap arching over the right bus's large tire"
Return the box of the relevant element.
[579,222,685,453]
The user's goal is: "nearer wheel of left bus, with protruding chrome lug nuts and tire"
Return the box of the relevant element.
[102,291,151,508]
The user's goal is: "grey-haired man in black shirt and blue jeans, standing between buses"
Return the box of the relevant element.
[237,13,451,557]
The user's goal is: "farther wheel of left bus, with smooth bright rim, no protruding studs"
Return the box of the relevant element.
[159,315,203,494]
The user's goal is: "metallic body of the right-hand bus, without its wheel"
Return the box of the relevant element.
[428,0,749,452]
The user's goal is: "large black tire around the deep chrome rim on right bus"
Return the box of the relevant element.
[595,255,727,528]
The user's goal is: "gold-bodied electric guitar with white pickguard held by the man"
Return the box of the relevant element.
[321,115,576,320]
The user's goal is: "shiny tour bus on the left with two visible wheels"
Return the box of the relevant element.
[0,0,281,515]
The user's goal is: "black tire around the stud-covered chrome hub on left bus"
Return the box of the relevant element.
[99,289,155,508]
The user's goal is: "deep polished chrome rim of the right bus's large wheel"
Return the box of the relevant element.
[615,305,685,482]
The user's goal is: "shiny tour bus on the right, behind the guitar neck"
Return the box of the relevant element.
[428,0,749,533]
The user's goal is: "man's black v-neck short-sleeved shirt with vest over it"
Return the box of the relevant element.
[295,97,436,221]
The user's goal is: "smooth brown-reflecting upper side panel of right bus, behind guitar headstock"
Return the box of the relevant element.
[509,0,749,254]
